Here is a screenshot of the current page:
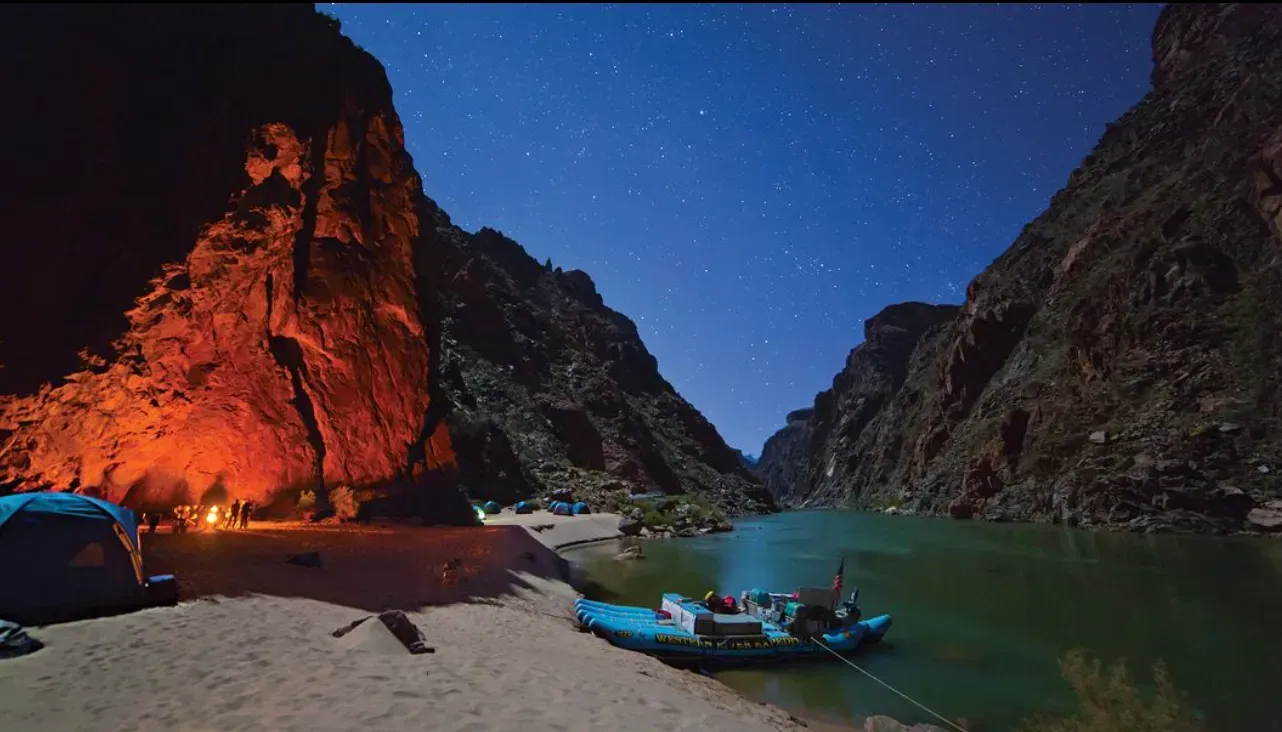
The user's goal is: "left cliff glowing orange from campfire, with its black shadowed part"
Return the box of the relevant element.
[0,6,454,515]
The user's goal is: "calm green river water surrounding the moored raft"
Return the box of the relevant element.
[567,512,1282,732]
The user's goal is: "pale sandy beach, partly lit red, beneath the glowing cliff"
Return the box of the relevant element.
[0,514,830,732]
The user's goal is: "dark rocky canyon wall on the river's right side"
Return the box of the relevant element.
[763,4,1282,532]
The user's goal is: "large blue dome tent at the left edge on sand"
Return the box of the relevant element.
[0,492,177,626]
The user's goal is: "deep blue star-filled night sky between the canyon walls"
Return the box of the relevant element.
[328,4,1160,454]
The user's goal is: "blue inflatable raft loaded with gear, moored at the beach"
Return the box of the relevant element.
[574,591,891,665]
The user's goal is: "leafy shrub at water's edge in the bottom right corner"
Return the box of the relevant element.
[1020,651,1203,732]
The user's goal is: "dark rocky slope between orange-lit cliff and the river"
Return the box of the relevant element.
[436,223,773,514]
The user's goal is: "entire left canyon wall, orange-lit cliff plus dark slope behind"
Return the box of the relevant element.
[0,5,773,522]
